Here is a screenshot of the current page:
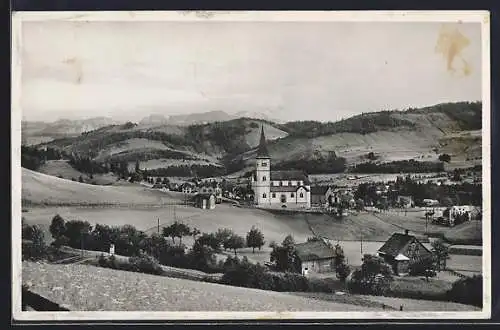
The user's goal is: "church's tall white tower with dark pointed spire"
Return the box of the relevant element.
[253,126,271,205]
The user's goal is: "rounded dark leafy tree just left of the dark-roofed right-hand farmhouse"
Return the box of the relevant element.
[349,254,393,295]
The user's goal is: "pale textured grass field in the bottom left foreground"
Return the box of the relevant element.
[22,262,373,312]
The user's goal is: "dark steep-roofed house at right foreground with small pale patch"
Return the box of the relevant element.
[377,230,432,276]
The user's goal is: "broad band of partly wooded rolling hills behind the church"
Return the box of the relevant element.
[22,102,481,174]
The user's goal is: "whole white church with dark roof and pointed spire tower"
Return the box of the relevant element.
[252,127,311,208]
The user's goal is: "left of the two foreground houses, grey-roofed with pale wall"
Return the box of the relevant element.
[295,240,335,275]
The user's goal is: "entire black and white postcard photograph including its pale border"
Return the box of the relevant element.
[11,11,491,321]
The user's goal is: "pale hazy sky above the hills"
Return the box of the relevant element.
[21,21,481,121]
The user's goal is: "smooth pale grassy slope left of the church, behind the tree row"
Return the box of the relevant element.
[21,168,182,206]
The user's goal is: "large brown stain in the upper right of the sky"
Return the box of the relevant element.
[435,26,471,76]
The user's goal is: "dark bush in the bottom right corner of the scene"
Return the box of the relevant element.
[446,275,483,307]
